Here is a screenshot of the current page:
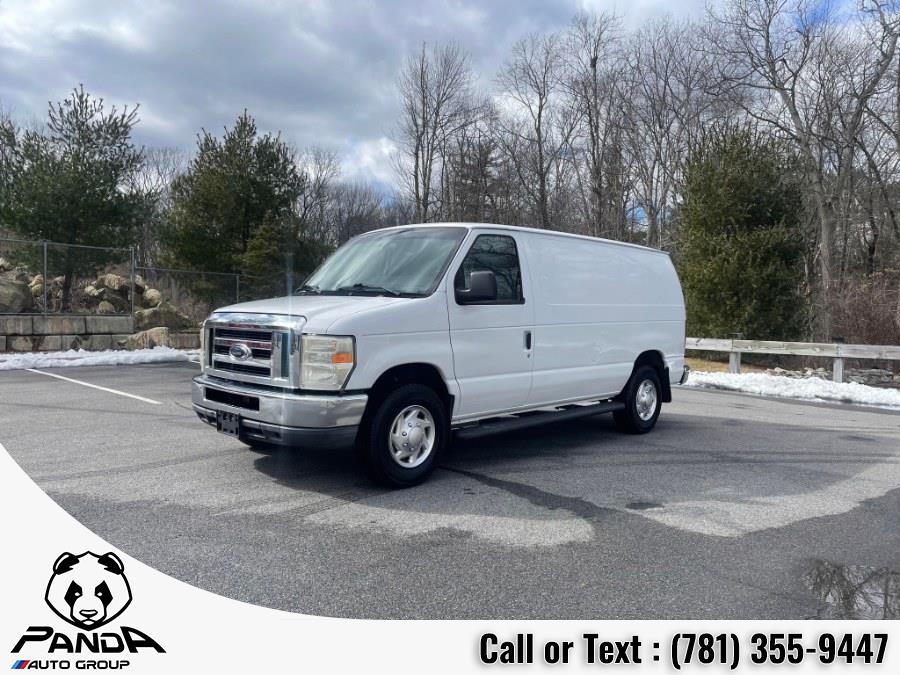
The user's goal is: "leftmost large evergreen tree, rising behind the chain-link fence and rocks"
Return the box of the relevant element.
[0,87,143,310]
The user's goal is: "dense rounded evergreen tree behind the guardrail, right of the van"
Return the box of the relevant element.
[678,127,806,340]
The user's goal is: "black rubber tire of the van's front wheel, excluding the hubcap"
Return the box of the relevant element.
[357,384,450,488]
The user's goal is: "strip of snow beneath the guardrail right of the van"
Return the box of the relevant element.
[686,371,900,408]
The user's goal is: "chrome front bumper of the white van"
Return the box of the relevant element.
[191,375,369,446]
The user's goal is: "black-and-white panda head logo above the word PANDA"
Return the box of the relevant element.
[45,551,131,630]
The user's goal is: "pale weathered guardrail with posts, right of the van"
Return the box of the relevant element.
[684,337,900,382]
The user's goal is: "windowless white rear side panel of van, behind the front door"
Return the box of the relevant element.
[525,233,684,404]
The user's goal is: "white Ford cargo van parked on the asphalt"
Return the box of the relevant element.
[192,223,687,486]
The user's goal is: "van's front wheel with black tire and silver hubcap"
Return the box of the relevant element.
[359,384,450,488]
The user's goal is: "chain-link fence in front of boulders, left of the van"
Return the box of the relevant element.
[0,238,241,328]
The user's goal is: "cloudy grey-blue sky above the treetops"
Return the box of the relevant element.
[0,0,703,182]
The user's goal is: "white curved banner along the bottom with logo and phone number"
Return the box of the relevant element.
[0,446,900,675]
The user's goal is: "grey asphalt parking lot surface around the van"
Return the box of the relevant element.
[0,363,900,619]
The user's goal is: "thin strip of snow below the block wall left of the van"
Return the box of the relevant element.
[0,347,200,370]
